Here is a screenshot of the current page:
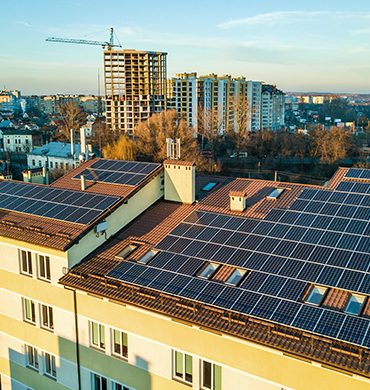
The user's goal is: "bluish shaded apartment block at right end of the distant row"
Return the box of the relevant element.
[261,84,285,131]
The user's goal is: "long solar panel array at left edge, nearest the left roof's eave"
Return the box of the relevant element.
[0,181,120,225]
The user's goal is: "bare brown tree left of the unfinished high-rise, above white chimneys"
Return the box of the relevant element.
[58,100,86,142]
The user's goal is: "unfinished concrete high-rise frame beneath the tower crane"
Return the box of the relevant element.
[104,50,167,134]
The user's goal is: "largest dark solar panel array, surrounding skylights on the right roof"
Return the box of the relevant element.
[107,181,370,347]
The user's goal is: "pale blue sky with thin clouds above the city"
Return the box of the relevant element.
[0,0,370,95]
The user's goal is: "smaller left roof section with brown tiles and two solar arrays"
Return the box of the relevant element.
[0,159,161,250]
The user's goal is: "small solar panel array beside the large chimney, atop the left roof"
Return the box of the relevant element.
[73,159,161,187]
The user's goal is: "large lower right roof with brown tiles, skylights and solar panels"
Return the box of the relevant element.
[60,168,370,376]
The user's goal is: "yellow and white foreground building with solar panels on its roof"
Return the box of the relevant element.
[0,159,370,390]
